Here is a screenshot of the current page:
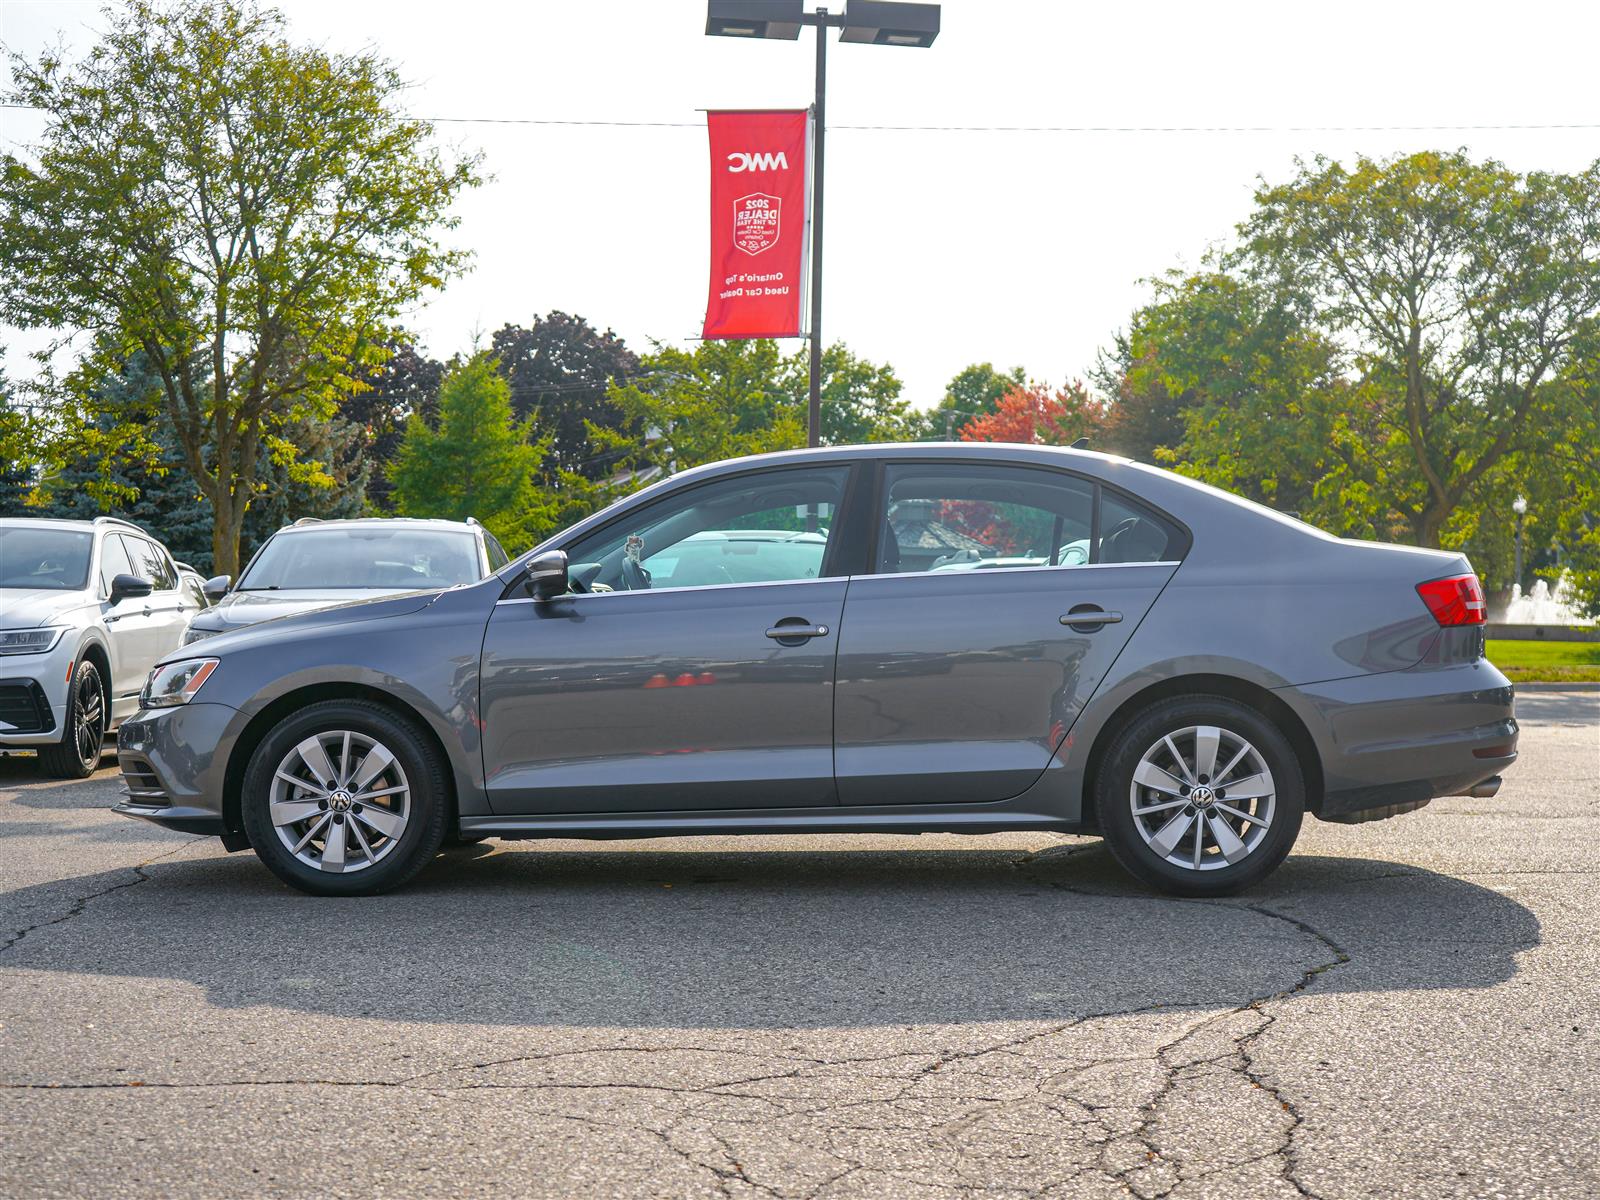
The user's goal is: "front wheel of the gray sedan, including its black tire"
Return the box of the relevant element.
[242,701,450,896]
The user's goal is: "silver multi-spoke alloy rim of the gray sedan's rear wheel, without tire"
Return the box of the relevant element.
[1128,725,1277,870]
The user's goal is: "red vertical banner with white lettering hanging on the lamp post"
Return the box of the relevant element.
[702,109,810,339]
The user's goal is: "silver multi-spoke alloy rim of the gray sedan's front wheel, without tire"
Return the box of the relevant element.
[269,730,411,874]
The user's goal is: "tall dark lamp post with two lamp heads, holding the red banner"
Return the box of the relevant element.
[706,0,939,446]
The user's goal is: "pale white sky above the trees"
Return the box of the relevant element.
[0,0,1600,405]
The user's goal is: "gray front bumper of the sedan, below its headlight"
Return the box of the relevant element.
[112,701,242,835]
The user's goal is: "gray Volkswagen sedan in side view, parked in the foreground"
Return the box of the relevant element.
[117,443,1517,896]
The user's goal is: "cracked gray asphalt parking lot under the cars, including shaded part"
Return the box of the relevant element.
[0,693,1600,1198]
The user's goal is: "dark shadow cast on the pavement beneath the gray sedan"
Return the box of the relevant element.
[0,838,1539,1029]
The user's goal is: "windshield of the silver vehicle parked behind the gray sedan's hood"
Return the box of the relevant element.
[238,525,482,592]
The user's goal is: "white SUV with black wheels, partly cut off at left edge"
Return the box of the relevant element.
[0,517,202,779]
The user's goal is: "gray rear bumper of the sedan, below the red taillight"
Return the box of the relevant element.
[1277,659,1517,821]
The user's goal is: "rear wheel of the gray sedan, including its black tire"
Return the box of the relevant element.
[1094,696,1306,896]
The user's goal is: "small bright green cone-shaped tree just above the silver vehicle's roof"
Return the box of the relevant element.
[390,354,554,544]
